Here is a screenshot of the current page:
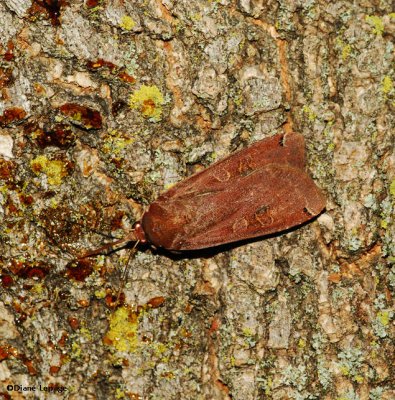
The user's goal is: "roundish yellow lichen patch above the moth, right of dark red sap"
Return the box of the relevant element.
[129,85,165,122]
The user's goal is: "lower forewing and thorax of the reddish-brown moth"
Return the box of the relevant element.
[143,163,325,250]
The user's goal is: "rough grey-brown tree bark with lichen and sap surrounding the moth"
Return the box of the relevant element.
[0,0,395,400]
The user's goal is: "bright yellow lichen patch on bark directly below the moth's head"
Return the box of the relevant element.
[103,307,138,353]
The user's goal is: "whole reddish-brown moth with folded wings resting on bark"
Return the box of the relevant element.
[82,133,325,255]
